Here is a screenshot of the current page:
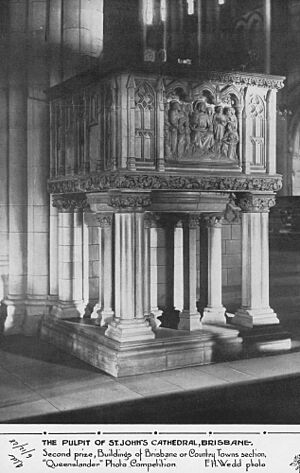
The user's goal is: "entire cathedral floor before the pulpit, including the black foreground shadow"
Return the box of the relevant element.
[0,324,300,424]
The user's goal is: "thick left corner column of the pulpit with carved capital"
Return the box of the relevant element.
[51,196,85,318]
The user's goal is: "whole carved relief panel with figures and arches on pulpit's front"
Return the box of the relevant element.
[165,80,241,164]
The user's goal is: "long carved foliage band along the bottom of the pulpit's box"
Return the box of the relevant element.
[48,173,282,194]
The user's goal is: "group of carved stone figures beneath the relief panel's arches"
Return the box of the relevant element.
[165,100,239,161]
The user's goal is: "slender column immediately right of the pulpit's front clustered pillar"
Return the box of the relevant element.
[144,213,162,327]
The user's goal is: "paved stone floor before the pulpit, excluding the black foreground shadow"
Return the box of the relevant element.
[0,337,300,423]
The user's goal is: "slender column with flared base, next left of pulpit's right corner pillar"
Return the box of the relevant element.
[202,214,226,325]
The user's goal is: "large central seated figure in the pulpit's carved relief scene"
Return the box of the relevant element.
[190,101,214,151]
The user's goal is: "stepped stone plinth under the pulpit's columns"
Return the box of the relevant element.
[41,317,242,377]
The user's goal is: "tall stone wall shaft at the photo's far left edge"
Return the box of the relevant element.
[5,0,27,333]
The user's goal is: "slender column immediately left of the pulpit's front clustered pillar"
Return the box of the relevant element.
[97,214,114,326]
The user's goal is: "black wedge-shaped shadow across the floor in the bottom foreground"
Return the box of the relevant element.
[8,376,300,424]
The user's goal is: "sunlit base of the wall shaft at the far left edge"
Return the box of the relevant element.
[0,299,26,335]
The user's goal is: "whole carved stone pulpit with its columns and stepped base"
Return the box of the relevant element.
[42,65,290,376]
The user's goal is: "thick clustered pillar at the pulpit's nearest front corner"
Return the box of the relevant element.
[105,205,154,342]
